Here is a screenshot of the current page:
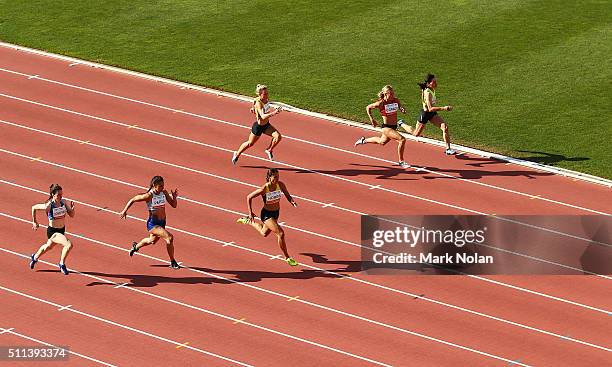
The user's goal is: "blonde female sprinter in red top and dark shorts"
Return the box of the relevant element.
[355,85,410,168]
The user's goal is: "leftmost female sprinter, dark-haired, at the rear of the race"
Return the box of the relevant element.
[30,184,74,275]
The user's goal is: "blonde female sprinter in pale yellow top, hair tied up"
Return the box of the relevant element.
[232,84,283,164]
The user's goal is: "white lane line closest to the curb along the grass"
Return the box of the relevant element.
[0,68,608,214]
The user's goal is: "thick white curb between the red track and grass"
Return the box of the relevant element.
[0,41,612,188]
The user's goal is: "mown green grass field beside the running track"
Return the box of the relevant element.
[0,0,612,178]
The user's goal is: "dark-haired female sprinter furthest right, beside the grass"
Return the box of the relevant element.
[400,74,456,155]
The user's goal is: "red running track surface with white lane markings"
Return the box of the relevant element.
[0,48,612,366]
